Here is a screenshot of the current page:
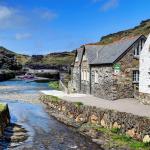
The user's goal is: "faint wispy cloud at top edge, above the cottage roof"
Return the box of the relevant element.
[101,0,119,11]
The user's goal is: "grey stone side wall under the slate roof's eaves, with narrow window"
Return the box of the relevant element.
[91,66,114,100]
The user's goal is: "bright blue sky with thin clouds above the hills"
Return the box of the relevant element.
[0,0,150,55]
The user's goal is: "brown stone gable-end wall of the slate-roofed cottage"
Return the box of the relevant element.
[114,43,139,99]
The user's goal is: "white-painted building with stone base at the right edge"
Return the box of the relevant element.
[139,35,150,104]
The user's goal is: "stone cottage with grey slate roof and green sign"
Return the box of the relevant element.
[72,35,146,100]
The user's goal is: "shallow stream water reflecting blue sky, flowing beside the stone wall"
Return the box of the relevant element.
[0,81,100,150]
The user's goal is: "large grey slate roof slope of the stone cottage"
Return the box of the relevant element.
[81,36,144,64]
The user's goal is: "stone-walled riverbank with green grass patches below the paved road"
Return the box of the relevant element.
[41,95,150,150]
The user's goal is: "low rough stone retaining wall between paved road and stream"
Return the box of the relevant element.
[41,96,150,145]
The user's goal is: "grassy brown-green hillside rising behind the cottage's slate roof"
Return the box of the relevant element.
[94,19,150,44]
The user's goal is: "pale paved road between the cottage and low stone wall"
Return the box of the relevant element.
[42,90,150,117]
